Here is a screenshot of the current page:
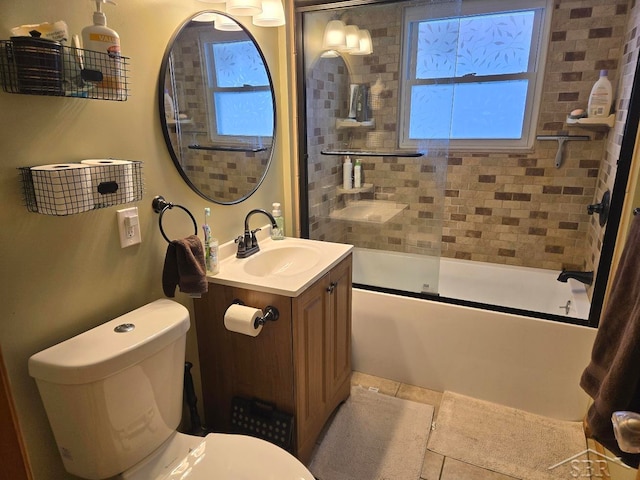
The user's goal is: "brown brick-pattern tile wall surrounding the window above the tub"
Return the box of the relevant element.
[307,0,635,270]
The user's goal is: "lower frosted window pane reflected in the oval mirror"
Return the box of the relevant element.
[214,90,273,137]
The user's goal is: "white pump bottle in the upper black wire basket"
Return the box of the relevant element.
[82,0,126,100]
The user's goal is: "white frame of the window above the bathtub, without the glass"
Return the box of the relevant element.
[398,0,553,151]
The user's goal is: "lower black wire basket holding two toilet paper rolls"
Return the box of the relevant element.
[18,160,144,216]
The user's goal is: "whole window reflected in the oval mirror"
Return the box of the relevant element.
[201,32,274,144]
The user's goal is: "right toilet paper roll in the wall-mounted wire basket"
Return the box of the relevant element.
[80,158,135,207]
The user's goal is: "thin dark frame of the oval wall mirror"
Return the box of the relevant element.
[157,10,278,205]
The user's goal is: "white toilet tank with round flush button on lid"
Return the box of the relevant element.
[29,299,189,479]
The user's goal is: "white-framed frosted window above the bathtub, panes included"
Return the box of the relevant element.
[399,0,550,149]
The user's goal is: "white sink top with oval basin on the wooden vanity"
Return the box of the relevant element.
[207,232,353,297]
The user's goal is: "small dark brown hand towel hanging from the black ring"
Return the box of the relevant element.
[162,235,208,297]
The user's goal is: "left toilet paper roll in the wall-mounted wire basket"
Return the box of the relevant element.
[31,163,94,215]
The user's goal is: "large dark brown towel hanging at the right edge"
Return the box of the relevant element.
[580,215,640,468]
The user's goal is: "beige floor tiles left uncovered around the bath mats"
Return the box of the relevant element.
[351,372,610,480]
